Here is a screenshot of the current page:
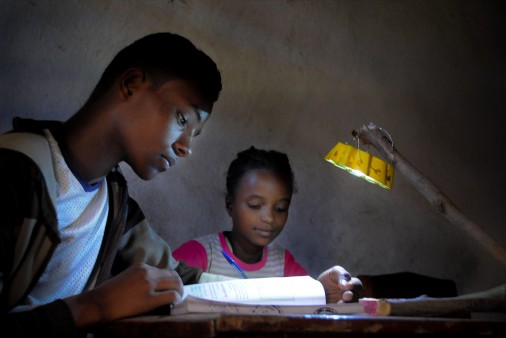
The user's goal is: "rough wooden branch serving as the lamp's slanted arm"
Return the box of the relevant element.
[354,123,506,265]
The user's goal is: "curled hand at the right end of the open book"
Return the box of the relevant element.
[318,265,364,304]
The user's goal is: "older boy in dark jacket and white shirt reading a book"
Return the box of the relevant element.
[0,33,364,337]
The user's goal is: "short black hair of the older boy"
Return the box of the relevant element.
[90,33,222,103]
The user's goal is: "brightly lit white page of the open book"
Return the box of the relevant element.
[184,276,325,305]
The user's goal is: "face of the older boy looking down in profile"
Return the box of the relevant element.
[120,80,212,180]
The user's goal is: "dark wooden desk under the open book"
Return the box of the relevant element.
[97,314,506,338]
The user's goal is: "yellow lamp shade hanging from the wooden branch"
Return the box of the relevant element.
[325,142,394,189]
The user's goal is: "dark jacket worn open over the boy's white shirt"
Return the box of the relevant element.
[0,118,202,337]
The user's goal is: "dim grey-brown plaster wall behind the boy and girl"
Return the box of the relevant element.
[0,0,506,293]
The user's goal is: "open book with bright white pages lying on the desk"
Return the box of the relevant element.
[171,276,364,315]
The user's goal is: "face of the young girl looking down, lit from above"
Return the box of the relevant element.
[226,169,292,249]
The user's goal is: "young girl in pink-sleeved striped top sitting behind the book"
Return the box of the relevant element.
[173,147,307,278]
